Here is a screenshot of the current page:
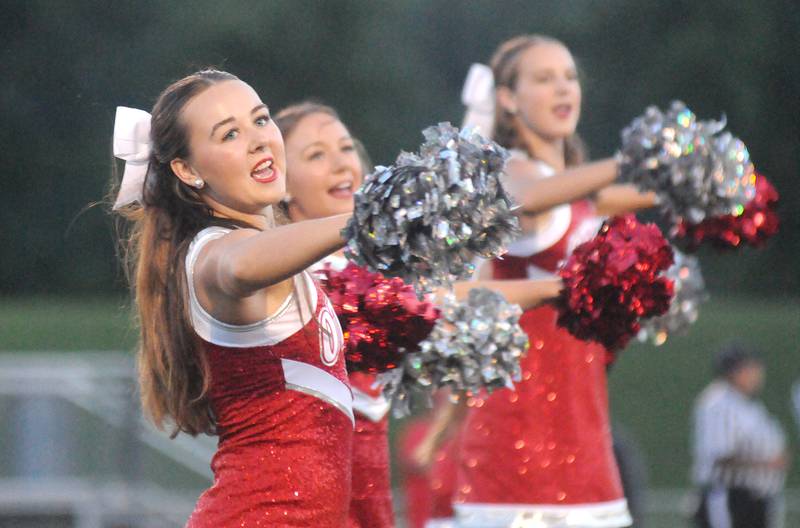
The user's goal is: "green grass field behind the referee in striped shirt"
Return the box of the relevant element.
[610,292,800,487]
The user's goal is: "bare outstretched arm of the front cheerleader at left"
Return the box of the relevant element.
[194,214,350,298]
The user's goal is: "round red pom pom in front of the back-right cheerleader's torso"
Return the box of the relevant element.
[558,215,673,351]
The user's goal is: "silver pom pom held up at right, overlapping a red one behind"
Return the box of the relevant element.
[620,101,755,224]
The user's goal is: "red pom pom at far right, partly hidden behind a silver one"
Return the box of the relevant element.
[673,174,780,251]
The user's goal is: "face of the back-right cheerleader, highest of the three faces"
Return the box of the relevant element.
[498,42,581,141]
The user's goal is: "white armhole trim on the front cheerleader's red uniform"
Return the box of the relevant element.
[186,227,317,348]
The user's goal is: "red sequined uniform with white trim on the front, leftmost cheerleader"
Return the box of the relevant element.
[186,228,353,528]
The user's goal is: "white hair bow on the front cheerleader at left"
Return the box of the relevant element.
[113,106,150,210]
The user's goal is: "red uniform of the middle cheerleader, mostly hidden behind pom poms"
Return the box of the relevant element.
[311,255,394,528]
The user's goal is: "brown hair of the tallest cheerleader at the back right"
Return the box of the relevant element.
[490,35,586,166]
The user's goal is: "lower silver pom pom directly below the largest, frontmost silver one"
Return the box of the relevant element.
[379,288,528,417]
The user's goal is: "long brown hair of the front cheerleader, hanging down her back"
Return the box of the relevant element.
[112,70,244,437]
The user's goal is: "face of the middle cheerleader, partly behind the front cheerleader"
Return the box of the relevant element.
[286,112,364,221]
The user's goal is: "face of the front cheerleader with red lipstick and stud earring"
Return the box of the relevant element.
[172,80,286,215]
